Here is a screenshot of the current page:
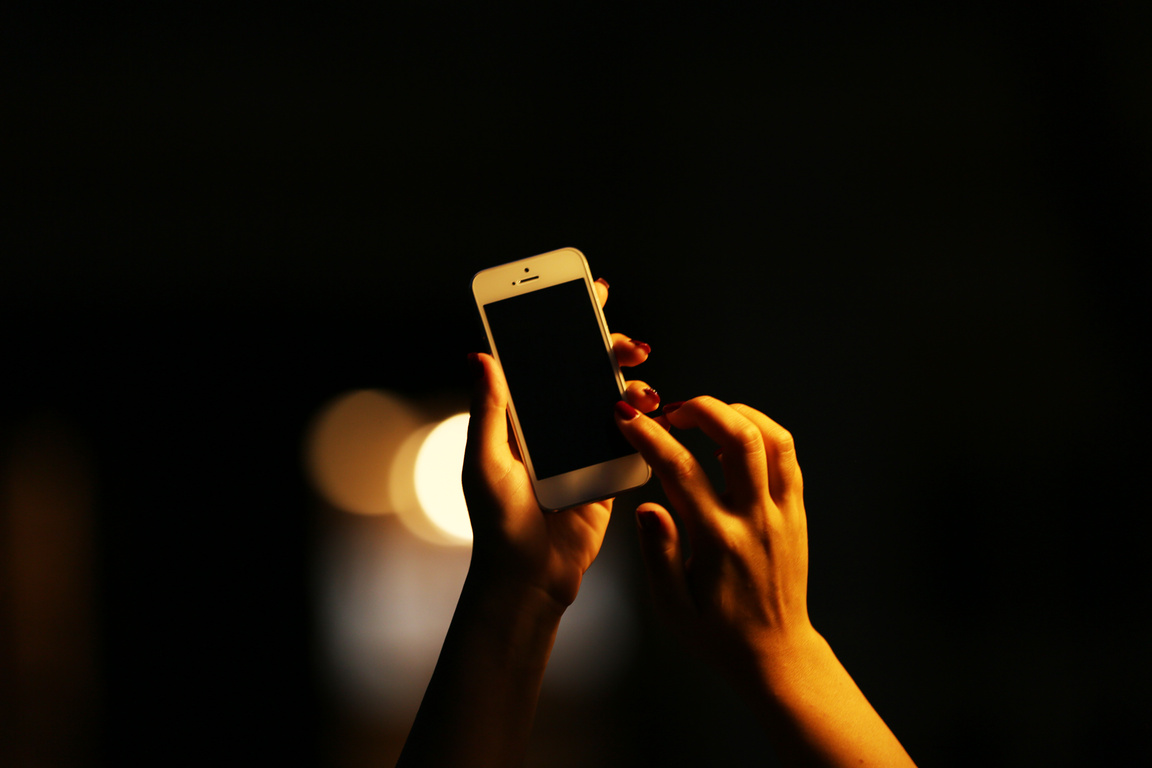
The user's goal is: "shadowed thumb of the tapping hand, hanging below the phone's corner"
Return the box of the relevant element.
[636,503,692,634]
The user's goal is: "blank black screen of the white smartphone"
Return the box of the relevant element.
[484,280,636,480]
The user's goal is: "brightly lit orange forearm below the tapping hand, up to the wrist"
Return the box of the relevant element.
[745,629,914,768]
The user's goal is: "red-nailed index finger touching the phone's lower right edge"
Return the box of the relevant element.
[616,403,720,535]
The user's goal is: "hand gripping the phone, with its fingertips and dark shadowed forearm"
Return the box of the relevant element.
[397,280,660,768]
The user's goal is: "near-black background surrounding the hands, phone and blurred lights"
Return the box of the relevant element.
[0,3,1152,766]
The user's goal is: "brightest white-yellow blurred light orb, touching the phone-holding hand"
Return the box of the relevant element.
[414,413,472,545]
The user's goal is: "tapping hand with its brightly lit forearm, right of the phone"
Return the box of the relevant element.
[616,397,914,767]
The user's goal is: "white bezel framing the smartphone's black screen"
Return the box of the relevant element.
[472,248,652,510]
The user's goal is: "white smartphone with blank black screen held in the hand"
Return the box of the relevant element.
[472,248,651,510]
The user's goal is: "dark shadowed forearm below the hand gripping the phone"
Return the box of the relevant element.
[399,573,562,767]
